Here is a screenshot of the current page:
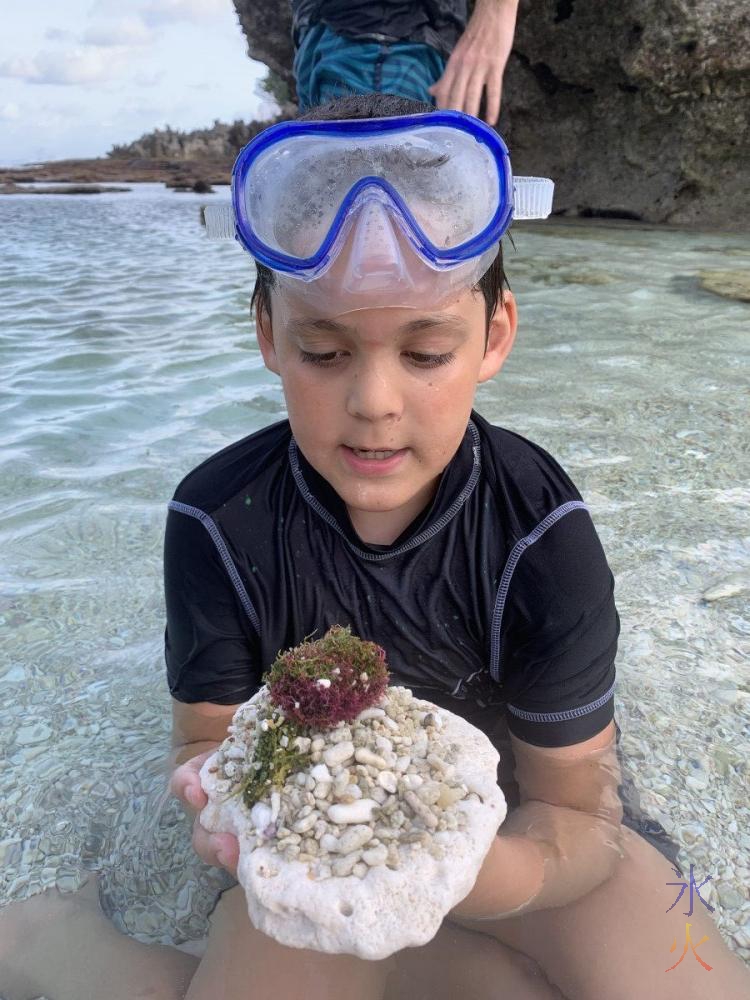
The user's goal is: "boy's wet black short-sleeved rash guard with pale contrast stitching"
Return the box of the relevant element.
[164,410,619,747]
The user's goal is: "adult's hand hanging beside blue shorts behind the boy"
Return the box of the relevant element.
[429,0,518,125]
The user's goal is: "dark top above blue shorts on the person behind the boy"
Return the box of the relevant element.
[292,0,467,56]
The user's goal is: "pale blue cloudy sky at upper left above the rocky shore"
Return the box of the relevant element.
[0,0,273,166]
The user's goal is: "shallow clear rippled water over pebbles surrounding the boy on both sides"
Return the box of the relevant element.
[0,185,750,958]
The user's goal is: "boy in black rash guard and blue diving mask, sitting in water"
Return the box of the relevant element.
[165,95,750,1000]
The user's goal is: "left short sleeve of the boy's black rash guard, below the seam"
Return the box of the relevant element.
[164,508,262,705]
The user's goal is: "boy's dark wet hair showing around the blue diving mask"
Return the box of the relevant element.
[250,94,510,350]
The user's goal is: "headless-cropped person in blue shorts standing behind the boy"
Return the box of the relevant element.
[292,0,518,125]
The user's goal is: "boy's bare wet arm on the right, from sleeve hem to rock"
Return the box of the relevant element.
[451,722,622,921]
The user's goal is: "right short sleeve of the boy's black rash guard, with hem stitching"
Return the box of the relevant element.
[501,507,620,747]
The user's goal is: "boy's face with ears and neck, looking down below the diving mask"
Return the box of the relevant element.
[258,289,516,544]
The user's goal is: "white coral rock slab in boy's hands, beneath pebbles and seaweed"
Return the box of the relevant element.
[201,688,506,960]
